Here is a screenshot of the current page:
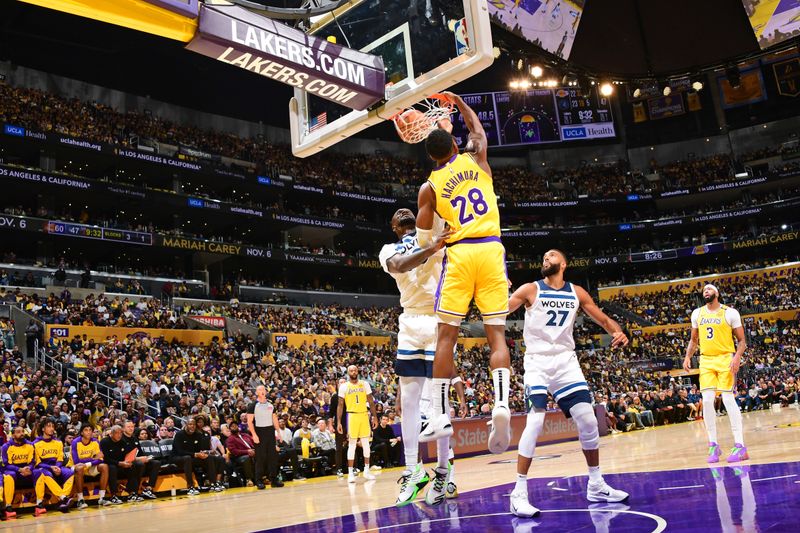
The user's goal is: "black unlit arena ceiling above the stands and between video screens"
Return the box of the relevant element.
[0,0,758,127]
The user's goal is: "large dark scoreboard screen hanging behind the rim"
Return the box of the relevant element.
[453,87,616,146]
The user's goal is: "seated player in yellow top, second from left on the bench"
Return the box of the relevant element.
[33,417,74,513]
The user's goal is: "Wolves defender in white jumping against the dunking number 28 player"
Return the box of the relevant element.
[378,209,450,507]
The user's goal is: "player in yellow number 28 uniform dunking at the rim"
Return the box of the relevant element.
[417,92,511,464]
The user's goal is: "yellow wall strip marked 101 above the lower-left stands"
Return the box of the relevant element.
[44,324,222,345]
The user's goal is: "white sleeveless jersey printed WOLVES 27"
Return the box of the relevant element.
[523,280,580,355]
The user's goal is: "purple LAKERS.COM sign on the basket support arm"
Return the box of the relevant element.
[187,5,386,110]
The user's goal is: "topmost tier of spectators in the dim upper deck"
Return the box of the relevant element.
[0,83,792,205]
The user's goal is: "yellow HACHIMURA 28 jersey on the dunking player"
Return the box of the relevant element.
[428,154,500,243]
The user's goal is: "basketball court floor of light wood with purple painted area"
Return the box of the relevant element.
[12,408,800,533]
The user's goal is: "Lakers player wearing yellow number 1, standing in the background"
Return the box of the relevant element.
[336,365,378,483]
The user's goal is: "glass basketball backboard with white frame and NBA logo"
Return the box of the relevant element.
[289,0,494,157]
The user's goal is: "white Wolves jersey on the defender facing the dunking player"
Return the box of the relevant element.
[378,217,444,313]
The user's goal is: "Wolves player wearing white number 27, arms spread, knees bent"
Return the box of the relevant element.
[509,250,628,517]
